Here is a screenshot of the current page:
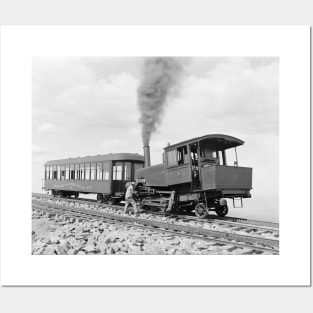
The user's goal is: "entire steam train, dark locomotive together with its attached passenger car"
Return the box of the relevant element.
[44,134,252,218]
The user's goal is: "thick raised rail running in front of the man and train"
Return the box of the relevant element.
[32,200,279,249]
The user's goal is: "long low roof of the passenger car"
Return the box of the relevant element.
[44,153,144,166]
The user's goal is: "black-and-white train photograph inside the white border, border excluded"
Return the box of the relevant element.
[32,56,279,255]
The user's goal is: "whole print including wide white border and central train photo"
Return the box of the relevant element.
[1,26,310,286]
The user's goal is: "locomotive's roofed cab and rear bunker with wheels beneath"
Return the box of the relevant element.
[164,135,252,217]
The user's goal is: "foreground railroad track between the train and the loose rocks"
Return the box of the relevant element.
[32,195,279,253]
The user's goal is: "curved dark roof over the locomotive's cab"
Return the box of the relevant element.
[164,134,244,151]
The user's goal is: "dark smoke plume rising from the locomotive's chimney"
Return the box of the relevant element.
[138,57,183,146]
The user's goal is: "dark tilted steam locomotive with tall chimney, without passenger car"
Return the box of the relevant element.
[135,134,252,218]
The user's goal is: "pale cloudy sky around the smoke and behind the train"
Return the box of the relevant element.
[32,57,279,221]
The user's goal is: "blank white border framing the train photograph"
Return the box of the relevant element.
[1,26,310,285]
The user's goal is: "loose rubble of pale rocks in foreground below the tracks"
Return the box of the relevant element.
[32,210,262,255]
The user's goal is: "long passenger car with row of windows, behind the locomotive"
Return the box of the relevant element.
[43,153,144,202]
